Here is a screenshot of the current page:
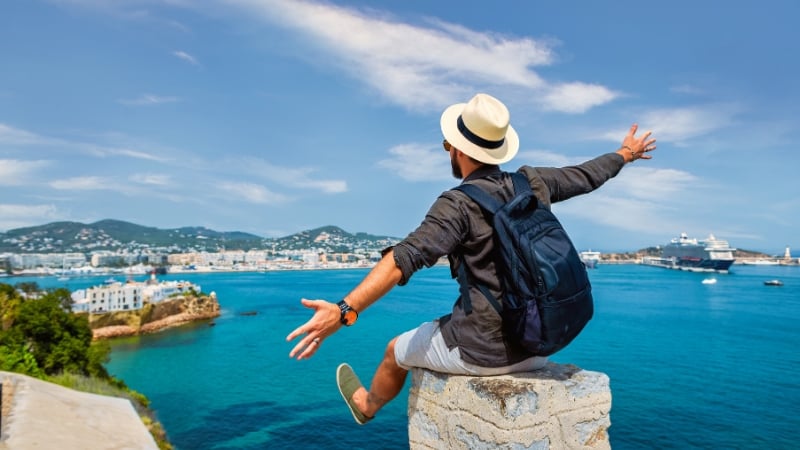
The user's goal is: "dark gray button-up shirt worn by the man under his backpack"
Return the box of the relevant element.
[394,153,625,367]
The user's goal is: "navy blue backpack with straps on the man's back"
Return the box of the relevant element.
[455,173,594,356]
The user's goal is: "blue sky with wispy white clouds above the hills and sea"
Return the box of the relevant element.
[0,0,800,254]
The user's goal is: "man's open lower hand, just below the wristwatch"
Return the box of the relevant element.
[286,298,342,360]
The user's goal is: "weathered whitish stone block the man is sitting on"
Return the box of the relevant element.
[408,362,611,450]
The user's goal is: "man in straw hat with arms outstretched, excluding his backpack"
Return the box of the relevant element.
[287,94,656,424]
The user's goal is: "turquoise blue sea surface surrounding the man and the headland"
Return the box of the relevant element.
[14,265,800,450]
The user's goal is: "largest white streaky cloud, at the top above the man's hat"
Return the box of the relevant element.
[229,0,617,113]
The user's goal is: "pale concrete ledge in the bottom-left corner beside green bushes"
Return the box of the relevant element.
[0,372,158,450]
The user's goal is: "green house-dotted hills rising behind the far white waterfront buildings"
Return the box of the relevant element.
[0,219,399,253]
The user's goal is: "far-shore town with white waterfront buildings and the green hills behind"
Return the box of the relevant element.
[0,221,399,278]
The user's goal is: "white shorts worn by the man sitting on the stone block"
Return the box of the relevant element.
[394,320,547,376]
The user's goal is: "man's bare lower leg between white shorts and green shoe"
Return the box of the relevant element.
[353,338,408,417]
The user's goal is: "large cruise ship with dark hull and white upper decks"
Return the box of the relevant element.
[642,233,736,273]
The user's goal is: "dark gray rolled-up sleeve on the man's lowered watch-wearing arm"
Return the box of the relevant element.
[394,191,468,286]
